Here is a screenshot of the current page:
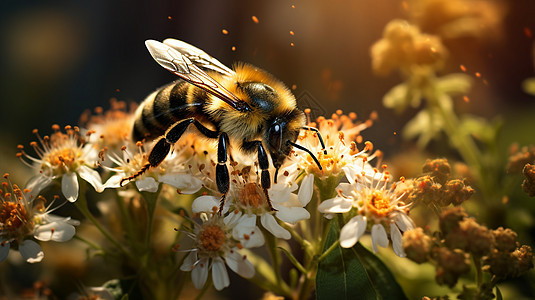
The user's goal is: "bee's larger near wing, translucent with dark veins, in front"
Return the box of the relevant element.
[145,40,250,111]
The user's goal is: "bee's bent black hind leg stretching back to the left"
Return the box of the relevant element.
[119,118,218,186]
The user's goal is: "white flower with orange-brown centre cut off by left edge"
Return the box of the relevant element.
[0,175,79,263]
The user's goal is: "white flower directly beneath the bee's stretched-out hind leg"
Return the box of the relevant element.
[100,142,202,194]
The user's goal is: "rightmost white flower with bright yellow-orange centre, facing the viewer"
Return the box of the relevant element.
[318,168,414,257]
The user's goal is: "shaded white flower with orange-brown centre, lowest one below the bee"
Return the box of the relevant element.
[180,213,256,291]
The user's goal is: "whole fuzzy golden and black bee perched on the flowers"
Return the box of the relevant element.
[121,39,326,214]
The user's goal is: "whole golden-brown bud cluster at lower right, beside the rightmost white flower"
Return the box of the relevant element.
[403,207,533,287]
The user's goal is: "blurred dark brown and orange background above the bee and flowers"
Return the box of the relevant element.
[0,0,535,298]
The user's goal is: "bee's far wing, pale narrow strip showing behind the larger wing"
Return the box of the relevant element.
[163,39,235,76]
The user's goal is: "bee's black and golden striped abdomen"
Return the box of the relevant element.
[132,80,200,141]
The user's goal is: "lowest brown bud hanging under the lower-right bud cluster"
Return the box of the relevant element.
[435,247,470,288]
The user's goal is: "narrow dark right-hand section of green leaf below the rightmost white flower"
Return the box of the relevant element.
[353,243,408,300]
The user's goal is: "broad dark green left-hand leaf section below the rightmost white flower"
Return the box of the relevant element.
[316,222,377,300]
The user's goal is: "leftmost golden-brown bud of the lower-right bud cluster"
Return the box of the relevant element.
[402,227,432,264]
